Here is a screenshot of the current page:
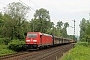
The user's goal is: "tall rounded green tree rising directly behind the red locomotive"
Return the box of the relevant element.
[31,8,52,33]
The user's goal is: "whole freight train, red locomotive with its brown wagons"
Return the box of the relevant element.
[26,32,73,49]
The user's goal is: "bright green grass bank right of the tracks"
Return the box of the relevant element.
[62,43,90,60]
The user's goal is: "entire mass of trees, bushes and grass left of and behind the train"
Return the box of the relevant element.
[0,2,76,56]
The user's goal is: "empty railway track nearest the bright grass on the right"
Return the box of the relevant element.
[20,44,73,60]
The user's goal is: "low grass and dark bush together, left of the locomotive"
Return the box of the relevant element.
[0,40,25,56]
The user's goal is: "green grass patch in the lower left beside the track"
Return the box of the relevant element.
[0,45,15,56]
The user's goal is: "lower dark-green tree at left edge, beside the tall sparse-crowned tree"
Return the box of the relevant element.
[1,14,13,37]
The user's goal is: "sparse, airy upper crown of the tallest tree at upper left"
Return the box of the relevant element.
[5,2,29,22]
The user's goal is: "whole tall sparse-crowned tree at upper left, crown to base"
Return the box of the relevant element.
[5,2,30,39]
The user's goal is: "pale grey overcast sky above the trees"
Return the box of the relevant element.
[0,0,90,35]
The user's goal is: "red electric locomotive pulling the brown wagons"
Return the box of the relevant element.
[26,32,53,49]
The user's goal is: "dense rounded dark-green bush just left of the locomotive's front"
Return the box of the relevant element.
[8,40,25,51]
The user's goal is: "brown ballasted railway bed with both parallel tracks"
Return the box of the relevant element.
[0,44,73,60]
